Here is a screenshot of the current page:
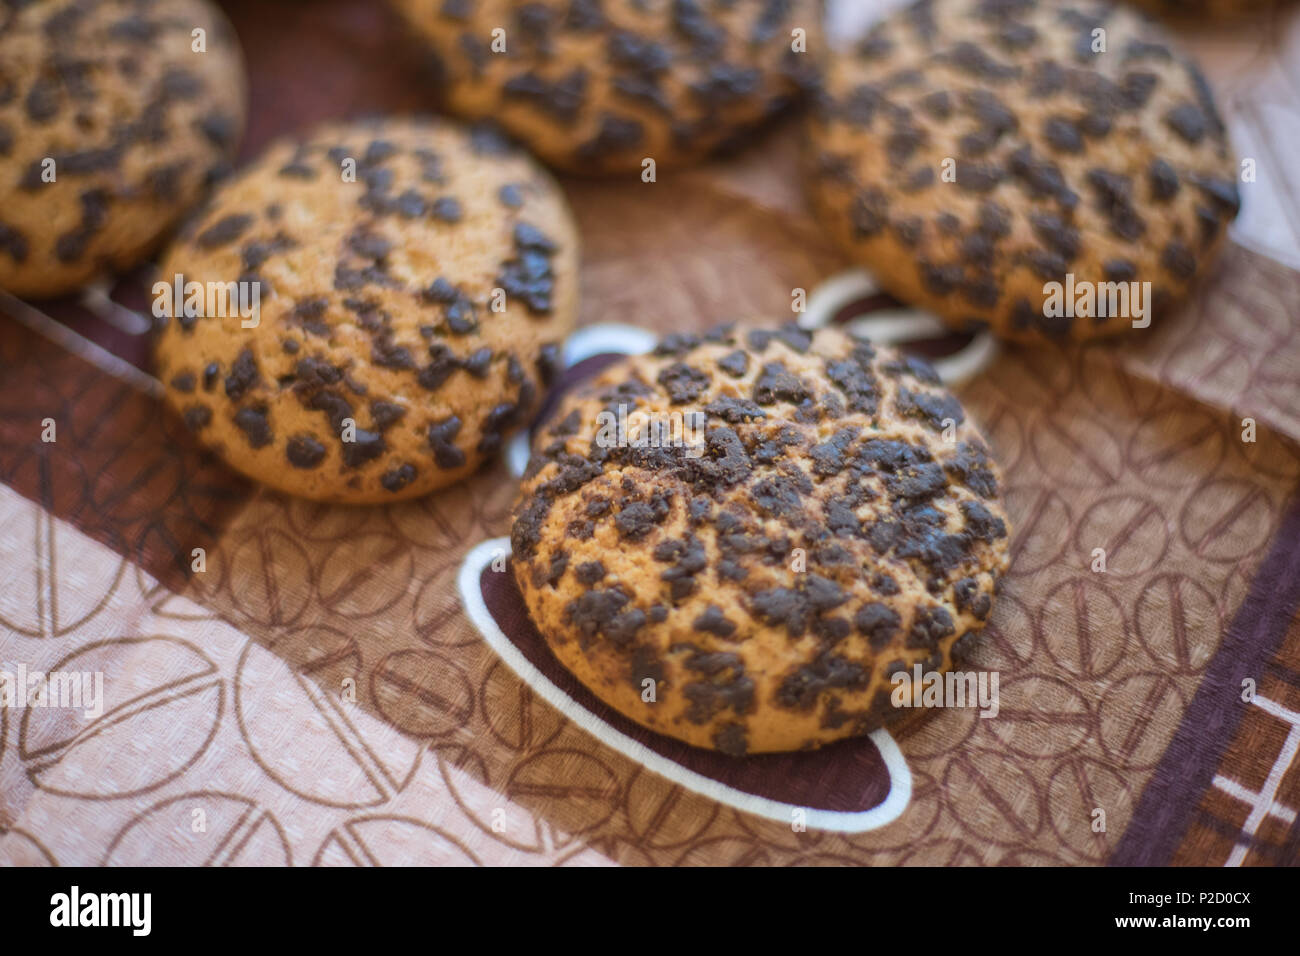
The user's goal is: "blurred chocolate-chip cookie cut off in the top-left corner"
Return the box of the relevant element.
[0,0,244,298]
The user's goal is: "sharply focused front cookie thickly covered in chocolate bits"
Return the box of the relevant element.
[511,325,1008,756]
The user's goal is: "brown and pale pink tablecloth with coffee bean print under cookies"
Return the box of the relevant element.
[0,0,1300,865]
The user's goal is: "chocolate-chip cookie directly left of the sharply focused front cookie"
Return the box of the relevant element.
[155,118,579,503]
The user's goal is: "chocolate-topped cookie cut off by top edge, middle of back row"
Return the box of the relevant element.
[393,0,822,174]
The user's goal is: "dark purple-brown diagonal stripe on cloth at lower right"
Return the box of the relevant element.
[1108,489,1300,866]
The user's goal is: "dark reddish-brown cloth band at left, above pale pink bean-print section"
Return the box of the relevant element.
[0,315,251,591]
